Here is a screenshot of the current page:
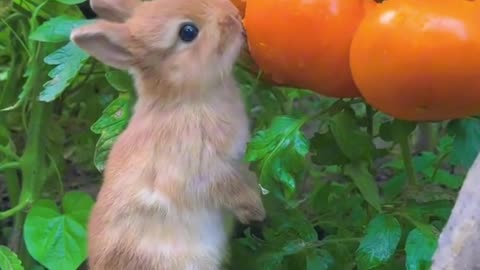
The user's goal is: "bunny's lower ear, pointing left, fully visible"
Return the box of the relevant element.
[70,21,134,69]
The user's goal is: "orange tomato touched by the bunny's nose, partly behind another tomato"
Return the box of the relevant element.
[244,0,366,97]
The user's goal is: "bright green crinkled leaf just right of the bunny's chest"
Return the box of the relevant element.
[246,116,309,191]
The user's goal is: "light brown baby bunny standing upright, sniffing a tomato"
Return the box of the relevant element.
[71,0,265,270]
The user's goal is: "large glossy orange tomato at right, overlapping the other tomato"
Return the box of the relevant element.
[350,0,480,121]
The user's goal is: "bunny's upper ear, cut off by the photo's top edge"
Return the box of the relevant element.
[90,0,141,22]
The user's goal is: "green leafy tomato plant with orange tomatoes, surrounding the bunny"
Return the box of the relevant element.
[0,0,480,270]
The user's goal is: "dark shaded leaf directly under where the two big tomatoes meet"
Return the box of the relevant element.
[330,111,374,161]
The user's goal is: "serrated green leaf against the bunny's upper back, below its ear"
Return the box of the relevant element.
[91,93,131,171]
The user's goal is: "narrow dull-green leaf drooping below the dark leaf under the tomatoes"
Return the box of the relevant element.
[345,163,381,211]
